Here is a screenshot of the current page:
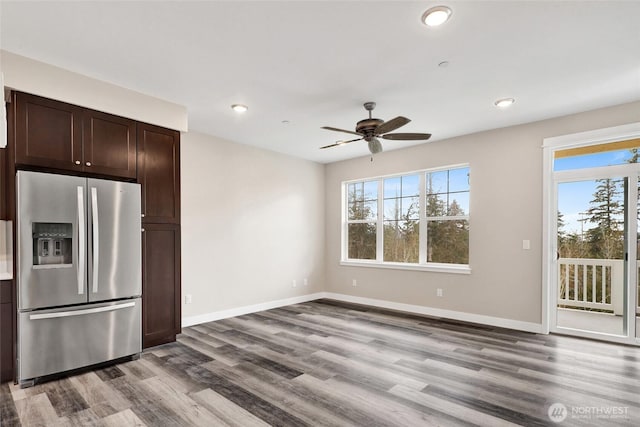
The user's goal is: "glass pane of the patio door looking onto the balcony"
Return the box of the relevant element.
[553,174,637,337]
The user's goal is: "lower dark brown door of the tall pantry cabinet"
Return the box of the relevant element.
[142,224,181,348]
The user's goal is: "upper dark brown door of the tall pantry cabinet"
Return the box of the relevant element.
[138,123,180,224]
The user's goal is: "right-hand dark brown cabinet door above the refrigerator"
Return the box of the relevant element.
[82,110,136,178]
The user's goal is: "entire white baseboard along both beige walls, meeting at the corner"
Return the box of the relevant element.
[182,292,544,334]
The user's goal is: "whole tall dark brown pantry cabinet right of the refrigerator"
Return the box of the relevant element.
[138,123,181,348]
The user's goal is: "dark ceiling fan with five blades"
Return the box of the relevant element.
[320,102,431,154]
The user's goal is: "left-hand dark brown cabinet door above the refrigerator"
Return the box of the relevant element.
[15,92,83,171]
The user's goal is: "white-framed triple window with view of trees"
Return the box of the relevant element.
[342,166,470,271]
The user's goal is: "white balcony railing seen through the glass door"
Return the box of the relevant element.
[558,258,624,315]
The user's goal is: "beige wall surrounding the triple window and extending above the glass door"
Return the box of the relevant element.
[325,102,640,323]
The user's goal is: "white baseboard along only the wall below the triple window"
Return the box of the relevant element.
[324,292,543,334]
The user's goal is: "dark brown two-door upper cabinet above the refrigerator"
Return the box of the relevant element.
[15,92,136,178]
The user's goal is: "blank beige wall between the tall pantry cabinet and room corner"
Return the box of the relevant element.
[181,132,325,317]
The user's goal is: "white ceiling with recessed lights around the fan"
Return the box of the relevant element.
[0,0,640,163]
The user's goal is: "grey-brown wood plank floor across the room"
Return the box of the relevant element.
[0,300,640,427]
